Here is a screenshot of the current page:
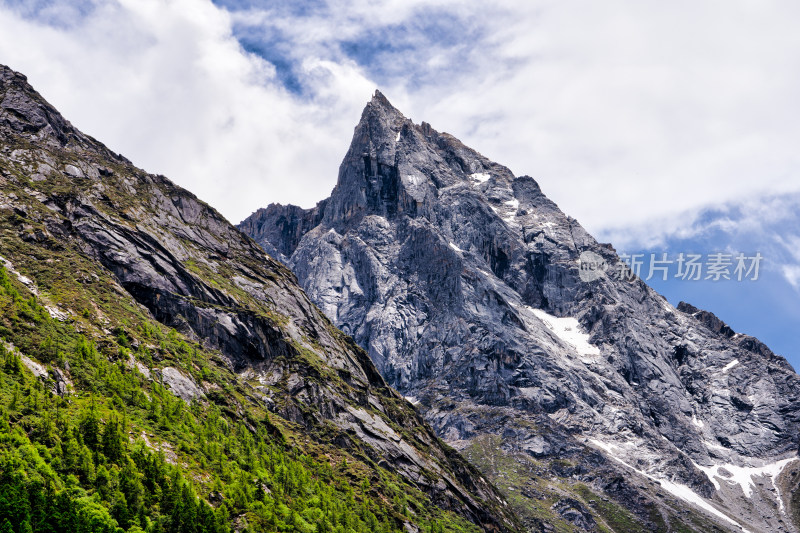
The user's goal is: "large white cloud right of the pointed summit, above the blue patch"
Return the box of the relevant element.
[398,1,800,235]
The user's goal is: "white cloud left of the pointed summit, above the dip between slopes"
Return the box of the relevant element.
[0,0,374,222]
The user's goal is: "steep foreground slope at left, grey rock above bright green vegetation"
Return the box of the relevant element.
[0,66,516,531]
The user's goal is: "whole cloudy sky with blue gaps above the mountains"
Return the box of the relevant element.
[0,0,800,366]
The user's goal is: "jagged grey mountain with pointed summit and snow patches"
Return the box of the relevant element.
[239,93,800,531]
